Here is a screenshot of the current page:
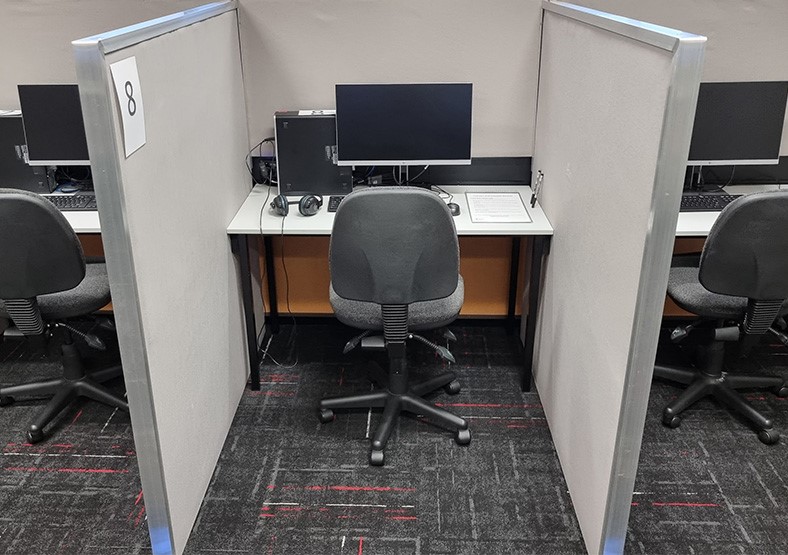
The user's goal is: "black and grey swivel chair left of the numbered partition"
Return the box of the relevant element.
[0,189,128,443]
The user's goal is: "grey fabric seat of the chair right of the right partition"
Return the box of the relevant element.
[668,267,788,319]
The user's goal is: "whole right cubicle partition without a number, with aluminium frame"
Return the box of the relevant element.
[532,2,705,553]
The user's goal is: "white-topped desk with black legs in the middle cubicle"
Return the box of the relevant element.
[227,185,553,391]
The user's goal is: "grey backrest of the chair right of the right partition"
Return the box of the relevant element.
[699,191,788,300]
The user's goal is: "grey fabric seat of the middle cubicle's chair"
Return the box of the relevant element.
[328,276,465,331]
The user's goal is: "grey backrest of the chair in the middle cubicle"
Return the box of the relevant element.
[329,187,460,305]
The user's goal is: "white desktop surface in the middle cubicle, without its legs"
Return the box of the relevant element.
[227,185,553,236]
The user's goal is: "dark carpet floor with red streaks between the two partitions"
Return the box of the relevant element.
[187,326,583,555]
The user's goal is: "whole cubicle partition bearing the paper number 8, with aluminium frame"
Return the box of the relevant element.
[73,2,249,554]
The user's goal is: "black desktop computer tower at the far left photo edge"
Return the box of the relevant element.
[0,112,54,194]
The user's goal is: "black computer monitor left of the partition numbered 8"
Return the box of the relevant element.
[18,85,90,166]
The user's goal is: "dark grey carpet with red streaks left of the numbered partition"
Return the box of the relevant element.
[0,322,150,555]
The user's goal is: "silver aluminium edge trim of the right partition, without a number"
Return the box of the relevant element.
[543,1,706,553]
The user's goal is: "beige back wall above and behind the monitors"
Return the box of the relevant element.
[0,0,788,156]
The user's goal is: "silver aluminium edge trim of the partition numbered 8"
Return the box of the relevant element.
[72,0,237,555]
